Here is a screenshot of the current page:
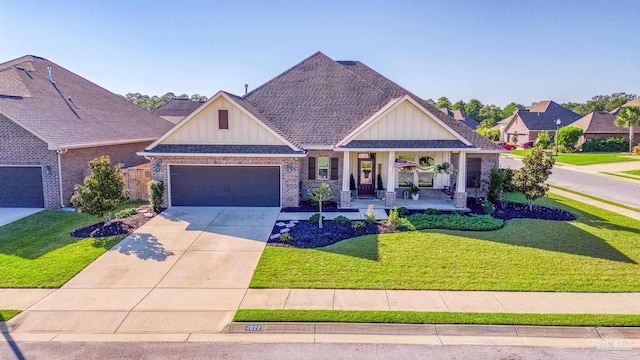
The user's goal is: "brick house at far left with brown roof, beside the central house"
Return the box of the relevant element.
[0,55,172,209]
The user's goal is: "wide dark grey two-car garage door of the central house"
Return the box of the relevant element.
[170,165,280,206]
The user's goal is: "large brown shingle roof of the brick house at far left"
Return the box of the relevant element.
[0,55,173,149]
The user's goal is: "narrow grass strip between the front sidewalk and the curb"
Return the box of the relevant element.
[233,309,640,326]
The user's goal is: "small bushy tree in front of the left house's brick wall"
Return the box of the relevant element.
[71,156,129,222]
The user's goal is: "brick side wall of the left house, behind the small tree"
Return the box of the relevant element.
[61,141,150,205]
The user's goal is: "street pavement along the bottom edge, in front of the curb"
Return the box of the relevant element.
[0,342,624,360]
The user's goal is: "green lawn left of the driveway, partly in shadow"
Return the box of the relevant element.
[0,202,145,288]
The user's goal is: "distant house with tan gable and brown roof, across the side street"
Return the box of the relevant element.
[497,100,580,144]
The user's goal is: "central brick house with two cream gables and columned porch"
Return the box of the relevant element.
[140,52,502,207]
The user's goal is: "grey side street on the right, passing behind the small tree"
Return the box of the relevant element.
[500,157,640,208]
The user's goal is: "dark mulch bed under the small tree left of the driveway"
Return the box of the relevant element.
[71,206,164,239]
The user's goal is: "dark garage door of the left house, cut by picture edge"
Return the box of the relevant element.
[0,166,44,208]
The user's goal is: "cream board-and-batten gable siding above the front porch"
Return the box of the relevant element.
[354,101,456,140]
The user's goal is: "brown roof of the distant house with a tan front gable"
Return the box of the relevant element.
[499,100,580,130]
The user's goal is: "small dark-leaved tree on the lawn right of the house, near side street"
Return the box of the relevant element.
[513,148,556,210]
